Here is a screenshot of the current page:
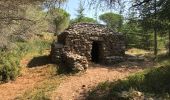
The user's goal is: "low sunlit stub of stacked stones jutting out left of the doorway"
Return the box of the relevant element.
[63,52,88,72]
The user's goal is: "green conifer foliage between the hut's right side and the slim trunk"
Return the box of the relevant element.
[122,19,153,50]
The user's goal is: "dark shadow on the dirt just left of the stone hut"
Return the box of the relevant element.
[27,55,51,68]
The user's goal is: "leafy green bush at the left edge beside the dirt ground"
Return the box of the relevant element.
[0,51,21,81]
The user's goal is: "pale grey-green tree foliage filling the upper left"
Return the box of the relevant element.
[0,1,49,49]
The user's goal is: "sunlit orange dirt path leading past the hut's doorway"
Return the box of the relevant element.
[51,62,153,100]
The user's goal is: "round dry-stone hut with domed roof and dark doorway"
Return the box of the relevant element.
[51,23,125,71]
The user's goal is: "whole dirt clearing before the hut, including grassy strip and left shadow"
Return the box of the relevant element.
[0,48,153,100]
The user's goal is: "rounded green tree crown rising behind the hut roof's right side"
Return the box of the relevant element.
[99,12,123,31]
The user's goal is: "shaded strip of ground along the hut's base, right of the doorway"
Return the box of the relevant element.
[90,54,156,70]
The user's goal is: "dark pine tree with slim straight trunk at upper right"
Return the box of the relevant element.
[133,0,170,56]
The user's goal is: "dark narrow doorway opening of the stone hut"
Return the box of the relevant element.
[91,41,101,63]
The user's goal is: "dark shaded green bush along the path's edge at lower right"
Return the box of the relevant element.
[106,65,170,97]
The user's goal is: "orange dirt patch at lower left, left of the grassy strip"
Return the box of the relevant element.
[0,54,51,100]
